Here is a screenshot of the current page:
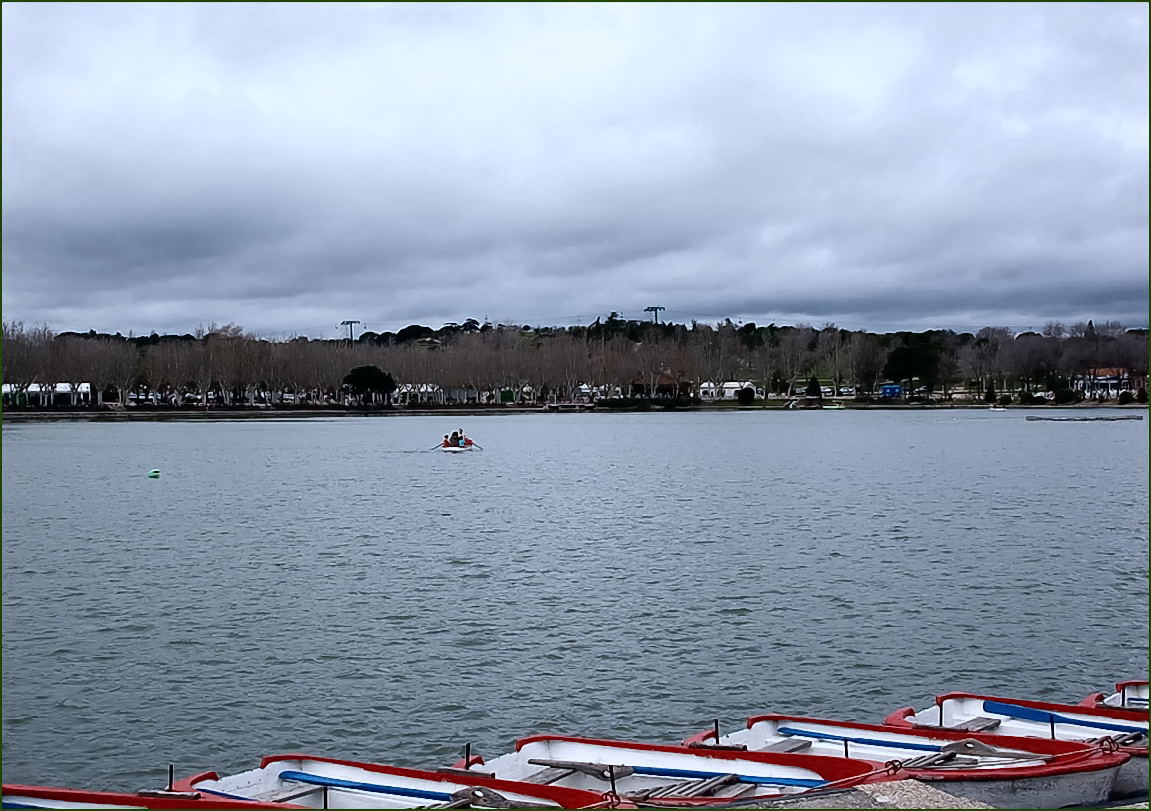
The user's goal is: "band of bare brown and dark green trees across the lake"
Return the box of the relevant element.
[2,313,1148,405]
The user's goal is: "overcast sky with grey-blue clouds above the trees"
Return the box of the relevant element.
[2,2,1149,337]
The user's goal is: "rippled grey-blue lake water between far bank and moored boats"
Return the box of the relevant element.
[3,410,1148,789]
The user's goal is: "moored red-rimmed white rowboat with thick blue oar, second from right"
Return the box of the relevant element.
[884,693,1148,797]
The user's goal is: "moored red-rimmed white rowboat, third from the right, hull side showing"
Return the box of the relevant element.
[684,714,1130,809]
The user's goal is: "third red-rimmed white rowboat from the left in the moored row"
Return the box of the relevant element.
[456,735,898,805]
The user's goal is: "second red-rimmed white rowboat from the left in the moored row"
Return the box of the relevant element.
[173,755,603,809]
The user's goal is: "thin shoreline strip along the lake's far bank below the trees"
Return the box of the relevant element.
[0,403,1148,422]
